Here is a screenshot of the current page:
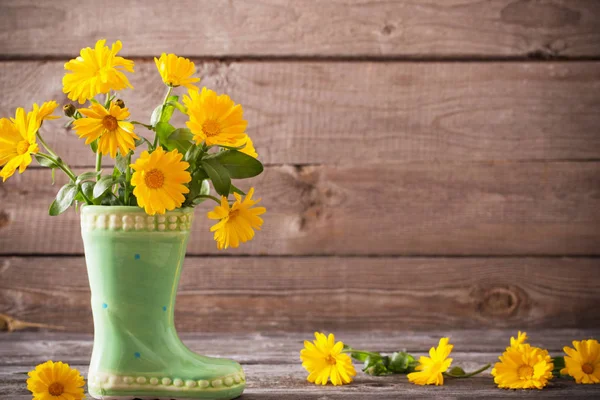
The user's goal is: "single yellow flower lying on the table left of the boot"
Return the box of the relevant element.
[27,361,85,400]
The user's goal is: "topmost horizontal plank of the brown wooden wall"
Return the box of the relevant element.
[0,0,600,58]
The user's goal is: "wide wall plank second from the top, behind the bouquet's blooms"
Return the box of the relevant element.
[0,61,600,166]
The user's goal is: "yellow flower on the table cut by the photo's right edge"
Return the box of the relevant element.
[560,339,600,384]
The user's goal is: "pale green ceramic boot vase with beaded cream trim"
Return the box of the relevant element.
[81,206,245,400]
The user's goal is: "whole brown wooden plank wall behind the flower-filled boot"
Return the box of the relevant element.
[0,0,600,332]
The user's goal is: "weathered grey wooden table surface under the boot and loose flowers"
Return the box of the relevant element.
[0,329,600,400]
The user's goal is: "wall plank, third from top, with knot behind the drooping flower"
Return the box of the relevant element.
[0,162,600,255]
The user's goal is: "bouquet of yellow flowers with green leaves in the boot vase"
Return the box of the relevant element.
[0,40,266,249]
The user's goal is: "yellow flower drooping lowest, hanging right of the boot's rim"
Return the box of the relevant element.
[208,188,267,250]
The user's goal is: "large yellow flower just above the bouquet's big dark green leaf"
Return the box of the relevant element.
[183,88,248,146]
